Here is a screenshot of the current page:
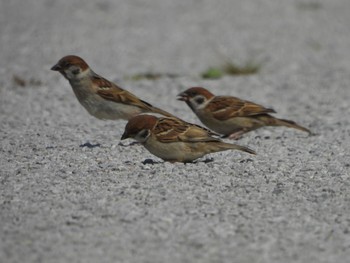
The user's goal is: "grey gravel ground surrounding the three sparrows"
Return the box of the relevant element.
[0,0,350,263]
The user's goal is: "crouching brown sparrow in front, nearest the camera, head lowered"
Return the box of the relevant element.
[121,114,255,163]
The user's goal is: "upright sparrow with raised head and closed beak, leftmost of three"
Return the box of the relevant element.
[51,55,173,120]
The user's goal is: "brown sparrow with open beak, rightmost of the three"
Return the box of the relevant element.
[178,87,311,139]
